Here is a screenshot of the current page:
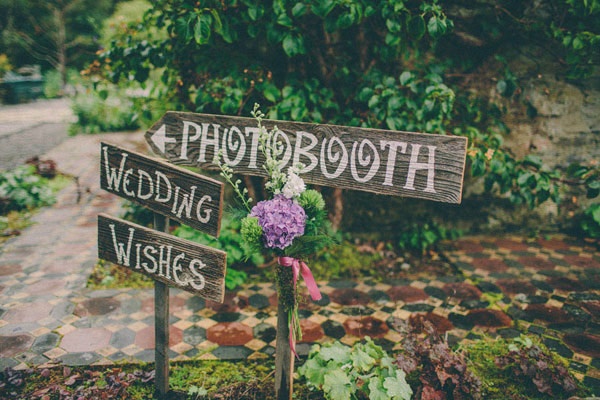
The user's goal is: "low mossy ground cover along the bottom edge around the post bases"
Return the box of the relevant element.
[0,360,323,400]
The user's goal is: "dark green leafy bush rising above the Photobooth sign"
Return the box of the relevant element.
[95,0,452,122]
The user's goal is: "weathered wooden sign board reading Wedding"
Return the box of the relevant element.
[100,143,224,236]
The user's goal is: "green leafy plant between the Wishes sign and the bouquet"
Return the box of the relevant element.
[173,216,265,290]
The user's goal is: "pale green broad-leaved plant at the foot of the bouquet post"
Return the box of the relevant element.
[298,337,412,400]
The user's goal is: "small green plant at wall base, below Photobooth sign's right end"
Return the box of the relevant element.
[398,221,461,254]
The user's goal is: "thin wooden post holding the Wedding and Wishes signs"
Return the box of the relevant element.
[154,213,169,399]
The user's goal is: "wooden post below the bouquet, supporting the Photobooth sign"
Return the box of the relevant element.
[275,265,295,400]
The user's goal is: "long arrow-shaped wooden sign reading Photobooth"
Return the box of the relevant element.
[145,112,467,203]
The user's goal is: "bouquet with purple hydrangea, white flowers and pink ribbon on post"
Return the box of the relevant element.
[215,105,331,354]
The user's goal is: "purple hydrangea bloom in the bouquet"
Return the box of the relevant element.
[250,195,306,250]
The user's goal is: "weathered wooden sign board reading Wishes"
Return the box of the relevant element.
[98,214,227,303]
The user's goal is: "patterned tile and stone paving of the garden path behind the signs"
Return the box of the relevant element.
[0,133,600,394]
